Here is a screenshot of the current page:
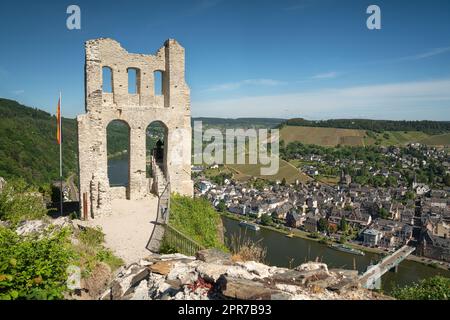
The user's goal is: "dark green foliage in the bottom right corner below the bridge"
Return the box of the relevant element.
[392,276,450,300]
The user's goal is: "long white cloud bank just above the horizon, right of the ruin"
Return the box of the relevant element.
[192,79,450,120]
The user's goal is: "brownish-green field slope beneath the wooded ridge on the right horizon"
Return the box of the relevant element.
[280,126,450,147]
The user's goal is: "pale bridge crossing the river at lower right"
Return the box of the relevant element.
[359,246,416,289]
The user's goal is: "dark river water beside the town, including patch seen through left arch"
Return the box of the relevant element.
[108,157,450,292]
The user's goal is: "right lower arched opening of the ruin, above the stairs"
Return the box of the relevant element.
[146,121,167,178]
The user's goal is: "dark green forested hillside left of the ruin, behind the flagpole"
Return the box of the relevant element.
[0,98,77,185]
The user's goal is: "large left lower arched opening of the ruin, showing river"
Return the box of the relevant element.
[106,120,130,187]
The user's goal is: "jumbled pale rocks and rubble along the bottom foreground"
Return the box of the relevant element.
[99,249,391,300]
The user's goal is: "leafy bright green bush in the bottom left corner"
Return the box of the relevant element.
[0,227,73,300]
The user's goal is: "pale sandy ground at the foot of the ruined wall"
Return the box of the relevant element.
[88,196,158,264]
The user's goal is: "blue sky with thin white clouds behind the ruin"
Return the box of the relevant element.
[0,0,450,120]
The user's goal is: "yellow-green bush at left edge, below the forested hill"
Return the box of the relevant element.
[0,179,47,224]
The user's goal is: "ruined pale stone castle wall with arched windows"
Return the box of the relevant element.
[77,38,193,217]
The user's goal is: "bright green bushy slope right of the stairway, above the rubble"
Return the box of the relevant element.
[169,194,226,250]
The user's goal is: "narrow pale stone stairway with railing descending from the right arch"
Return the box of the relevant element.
[147,159,170,253]
